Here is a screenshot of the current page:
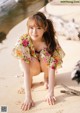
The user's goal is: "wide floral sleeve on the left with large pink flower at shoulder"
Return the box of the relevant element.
[13,34,31,63]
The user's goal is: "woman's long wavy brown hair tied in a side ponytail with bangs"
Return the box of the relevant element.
[27,12,56,55]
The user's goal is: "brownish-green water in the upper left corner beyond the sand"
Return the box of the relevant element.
[0,0,48,42]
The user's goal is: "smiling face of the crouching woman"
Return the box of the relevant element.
[28,20,45,41]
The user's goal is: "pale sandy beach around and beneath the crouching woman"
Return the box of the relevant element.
[0,2,80,113]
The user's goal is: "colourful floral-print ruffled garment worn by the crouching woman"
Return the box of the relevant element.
[13,34,65,69]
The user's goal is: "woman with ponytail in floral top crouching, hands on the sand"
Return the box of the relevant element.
[13,12,64,110]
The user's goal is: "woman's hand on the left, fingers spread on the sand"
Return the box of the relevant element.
[21,98,35,111]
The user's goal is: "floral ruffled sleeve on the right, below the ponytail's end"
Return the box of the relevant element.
[40,40,65,69]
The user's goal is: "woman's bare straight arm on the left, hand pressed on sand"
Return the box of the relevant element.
[20,60,34,110]
